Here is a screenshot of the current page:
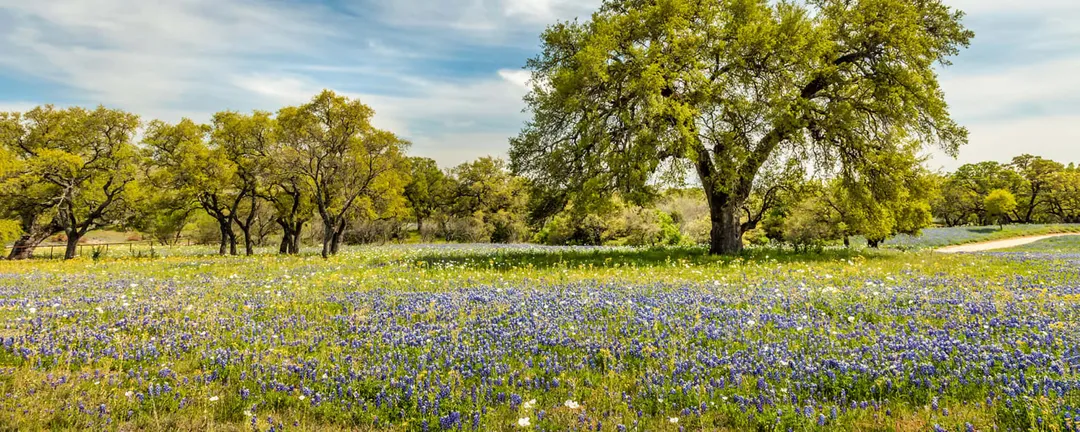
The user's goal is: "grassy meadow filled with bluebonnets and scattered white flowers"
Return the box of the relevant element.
[0,246,1080,431]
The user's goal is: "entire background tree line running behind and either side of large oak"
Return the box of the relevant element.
[0,91,1080,259]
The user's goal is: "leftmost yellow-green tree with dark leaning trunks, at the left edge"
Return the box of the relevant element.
[0,105,143,258]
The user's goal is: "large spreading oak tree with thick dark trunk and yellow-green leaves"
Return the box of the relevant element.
[510,0,973,253]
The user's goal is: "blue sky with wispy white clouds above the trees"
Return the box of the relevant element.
[0,0,1080,170]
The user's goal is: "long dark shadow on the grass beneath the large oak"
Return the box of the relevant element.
[413,247,896,269]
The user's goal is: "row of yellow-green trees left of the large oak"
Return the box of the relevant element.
[0,91,528,259]
